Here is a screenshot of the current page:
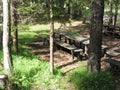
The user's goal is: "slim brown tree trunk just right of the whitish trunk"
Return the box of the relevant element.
[11,0,18,54]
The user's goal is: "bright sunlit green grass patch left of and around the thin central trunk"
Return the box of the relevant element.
[10,55,64,90]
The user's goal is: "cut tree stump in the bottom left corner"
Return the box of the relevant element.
[0,74,8,90]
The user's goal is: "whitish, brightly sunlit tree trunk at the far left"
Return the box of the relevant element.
[3,0,12,73]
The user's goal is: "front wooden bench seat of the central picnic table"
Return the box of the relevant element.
[55,41,83,60]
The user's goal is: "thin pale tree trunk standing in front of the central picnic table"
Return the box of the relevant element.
[50,0,54,74]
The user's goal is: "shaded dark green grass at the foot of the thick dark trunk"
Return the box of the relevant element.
[69,69,115,90]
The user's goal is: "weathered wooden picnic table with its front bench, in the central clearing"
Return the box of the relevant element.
[54,31,87,59]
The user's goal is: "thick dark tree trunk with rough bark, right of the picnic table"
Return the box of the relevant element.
[87,0,104,72]
